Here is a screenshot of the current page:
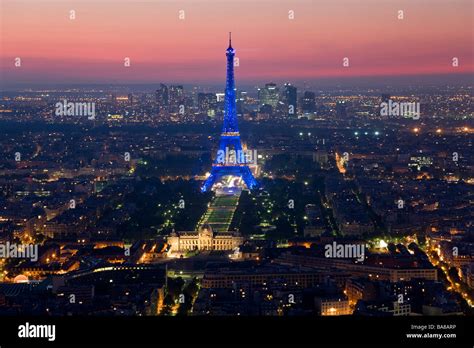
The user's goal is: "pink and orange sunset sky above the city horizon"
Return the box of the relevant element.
[0,0,474,84]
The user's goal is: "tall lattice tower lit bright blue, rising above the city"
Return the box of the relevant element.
[201,33,257,192]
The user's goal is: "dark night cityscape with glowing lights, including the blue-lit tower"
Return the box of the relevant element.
[0,1,474,346]
